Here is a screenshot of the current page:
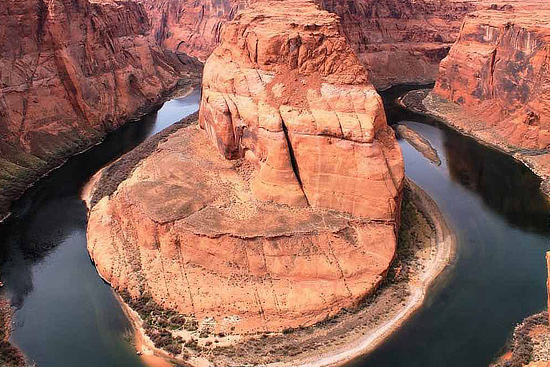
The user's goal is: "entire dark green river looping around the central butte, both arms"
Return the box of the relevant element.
[0,87,550,367]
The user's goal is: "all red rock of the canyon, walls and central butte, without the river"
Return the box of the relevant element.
[0,0,550,366]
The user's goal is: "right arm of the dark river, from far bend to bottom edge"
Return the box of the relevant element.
[349,87,550,367]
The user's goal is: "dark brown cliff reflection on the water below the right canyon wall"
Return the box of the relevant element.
[381,85,550,233]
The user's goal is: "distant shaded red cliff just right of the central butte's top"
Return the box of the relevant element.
[318,0,475,88]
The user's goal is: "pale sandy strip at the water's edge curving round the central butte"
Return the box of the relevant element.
[113,179,456,367]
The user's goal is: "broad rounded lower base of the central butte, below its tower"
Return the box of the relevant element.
[88,125,402,333]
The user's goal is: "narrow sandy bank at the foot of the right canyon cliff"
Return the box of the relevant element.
[396,89,550,200]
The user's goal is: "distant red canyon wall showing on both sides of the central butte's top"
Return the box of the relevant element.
[139,0,481,88]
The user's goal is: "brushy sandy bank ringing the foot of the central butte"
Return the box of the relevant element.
[83,112,456,367]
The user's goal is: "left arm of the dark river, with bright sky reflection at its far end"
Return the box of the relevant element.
[0,90,200,367]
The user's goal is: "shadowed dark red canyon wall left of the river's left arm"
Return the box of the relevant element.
[0,0,201,219]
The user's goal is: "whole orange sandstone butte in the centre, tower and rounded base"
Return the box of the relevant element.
[88,0,404,334]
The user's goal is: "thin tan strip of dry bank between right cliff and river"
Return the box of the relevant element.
[396,89,550,199]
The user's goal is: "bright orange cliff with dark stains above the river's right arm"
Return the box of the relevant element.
[432,1,550,191]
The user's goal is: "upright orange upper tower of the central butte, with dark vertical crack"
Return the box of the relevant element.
[200,1,403,220]
